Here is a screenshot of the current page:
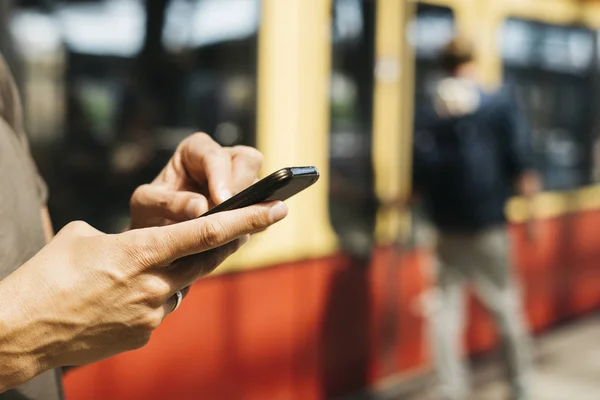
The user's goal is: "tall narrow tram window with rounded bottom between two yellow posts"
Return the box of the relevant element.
[330,0,377,257]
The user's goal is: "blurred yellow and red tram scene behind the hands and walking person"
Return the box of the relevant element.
[5,0,600,399]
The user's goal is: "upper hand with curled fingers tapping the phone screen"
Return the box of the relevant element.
[130,133,262,229]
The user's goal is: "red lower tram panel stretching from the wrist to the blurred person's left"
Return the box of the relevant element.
[65,250,423,399]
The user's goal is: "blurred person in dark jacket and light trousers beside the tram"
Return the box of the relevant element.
[413,37,539,400]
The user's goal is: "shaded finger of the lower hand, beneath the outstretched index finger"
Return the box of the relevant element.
[162,235,250,296]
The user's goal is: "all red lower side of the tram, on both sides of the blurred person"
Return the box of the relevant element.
[65,212,600,400]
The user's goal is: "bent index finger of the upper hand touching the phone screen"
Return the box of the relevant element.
[181,134,232,204]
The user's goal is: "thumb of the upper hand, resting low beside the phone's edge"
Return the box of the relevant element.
[131,185,208,222]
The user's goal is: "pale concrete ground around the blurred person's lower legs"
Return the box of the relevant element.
[351,315,600,400]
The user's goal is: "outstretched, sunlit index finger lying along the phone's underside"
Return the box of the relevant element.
[125,201,288,268]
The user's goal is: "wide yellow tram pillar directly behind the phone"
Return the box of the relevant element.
[221,0,337,270]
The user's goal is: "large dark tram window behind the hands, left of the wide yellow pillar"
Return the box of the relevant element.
[11,0,260,231]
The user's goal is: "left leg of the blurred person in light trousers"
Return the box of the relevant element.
[428,237,469,400]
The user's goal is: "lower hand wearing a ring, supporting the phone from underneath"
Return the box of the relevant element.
[0,202,287,389]
